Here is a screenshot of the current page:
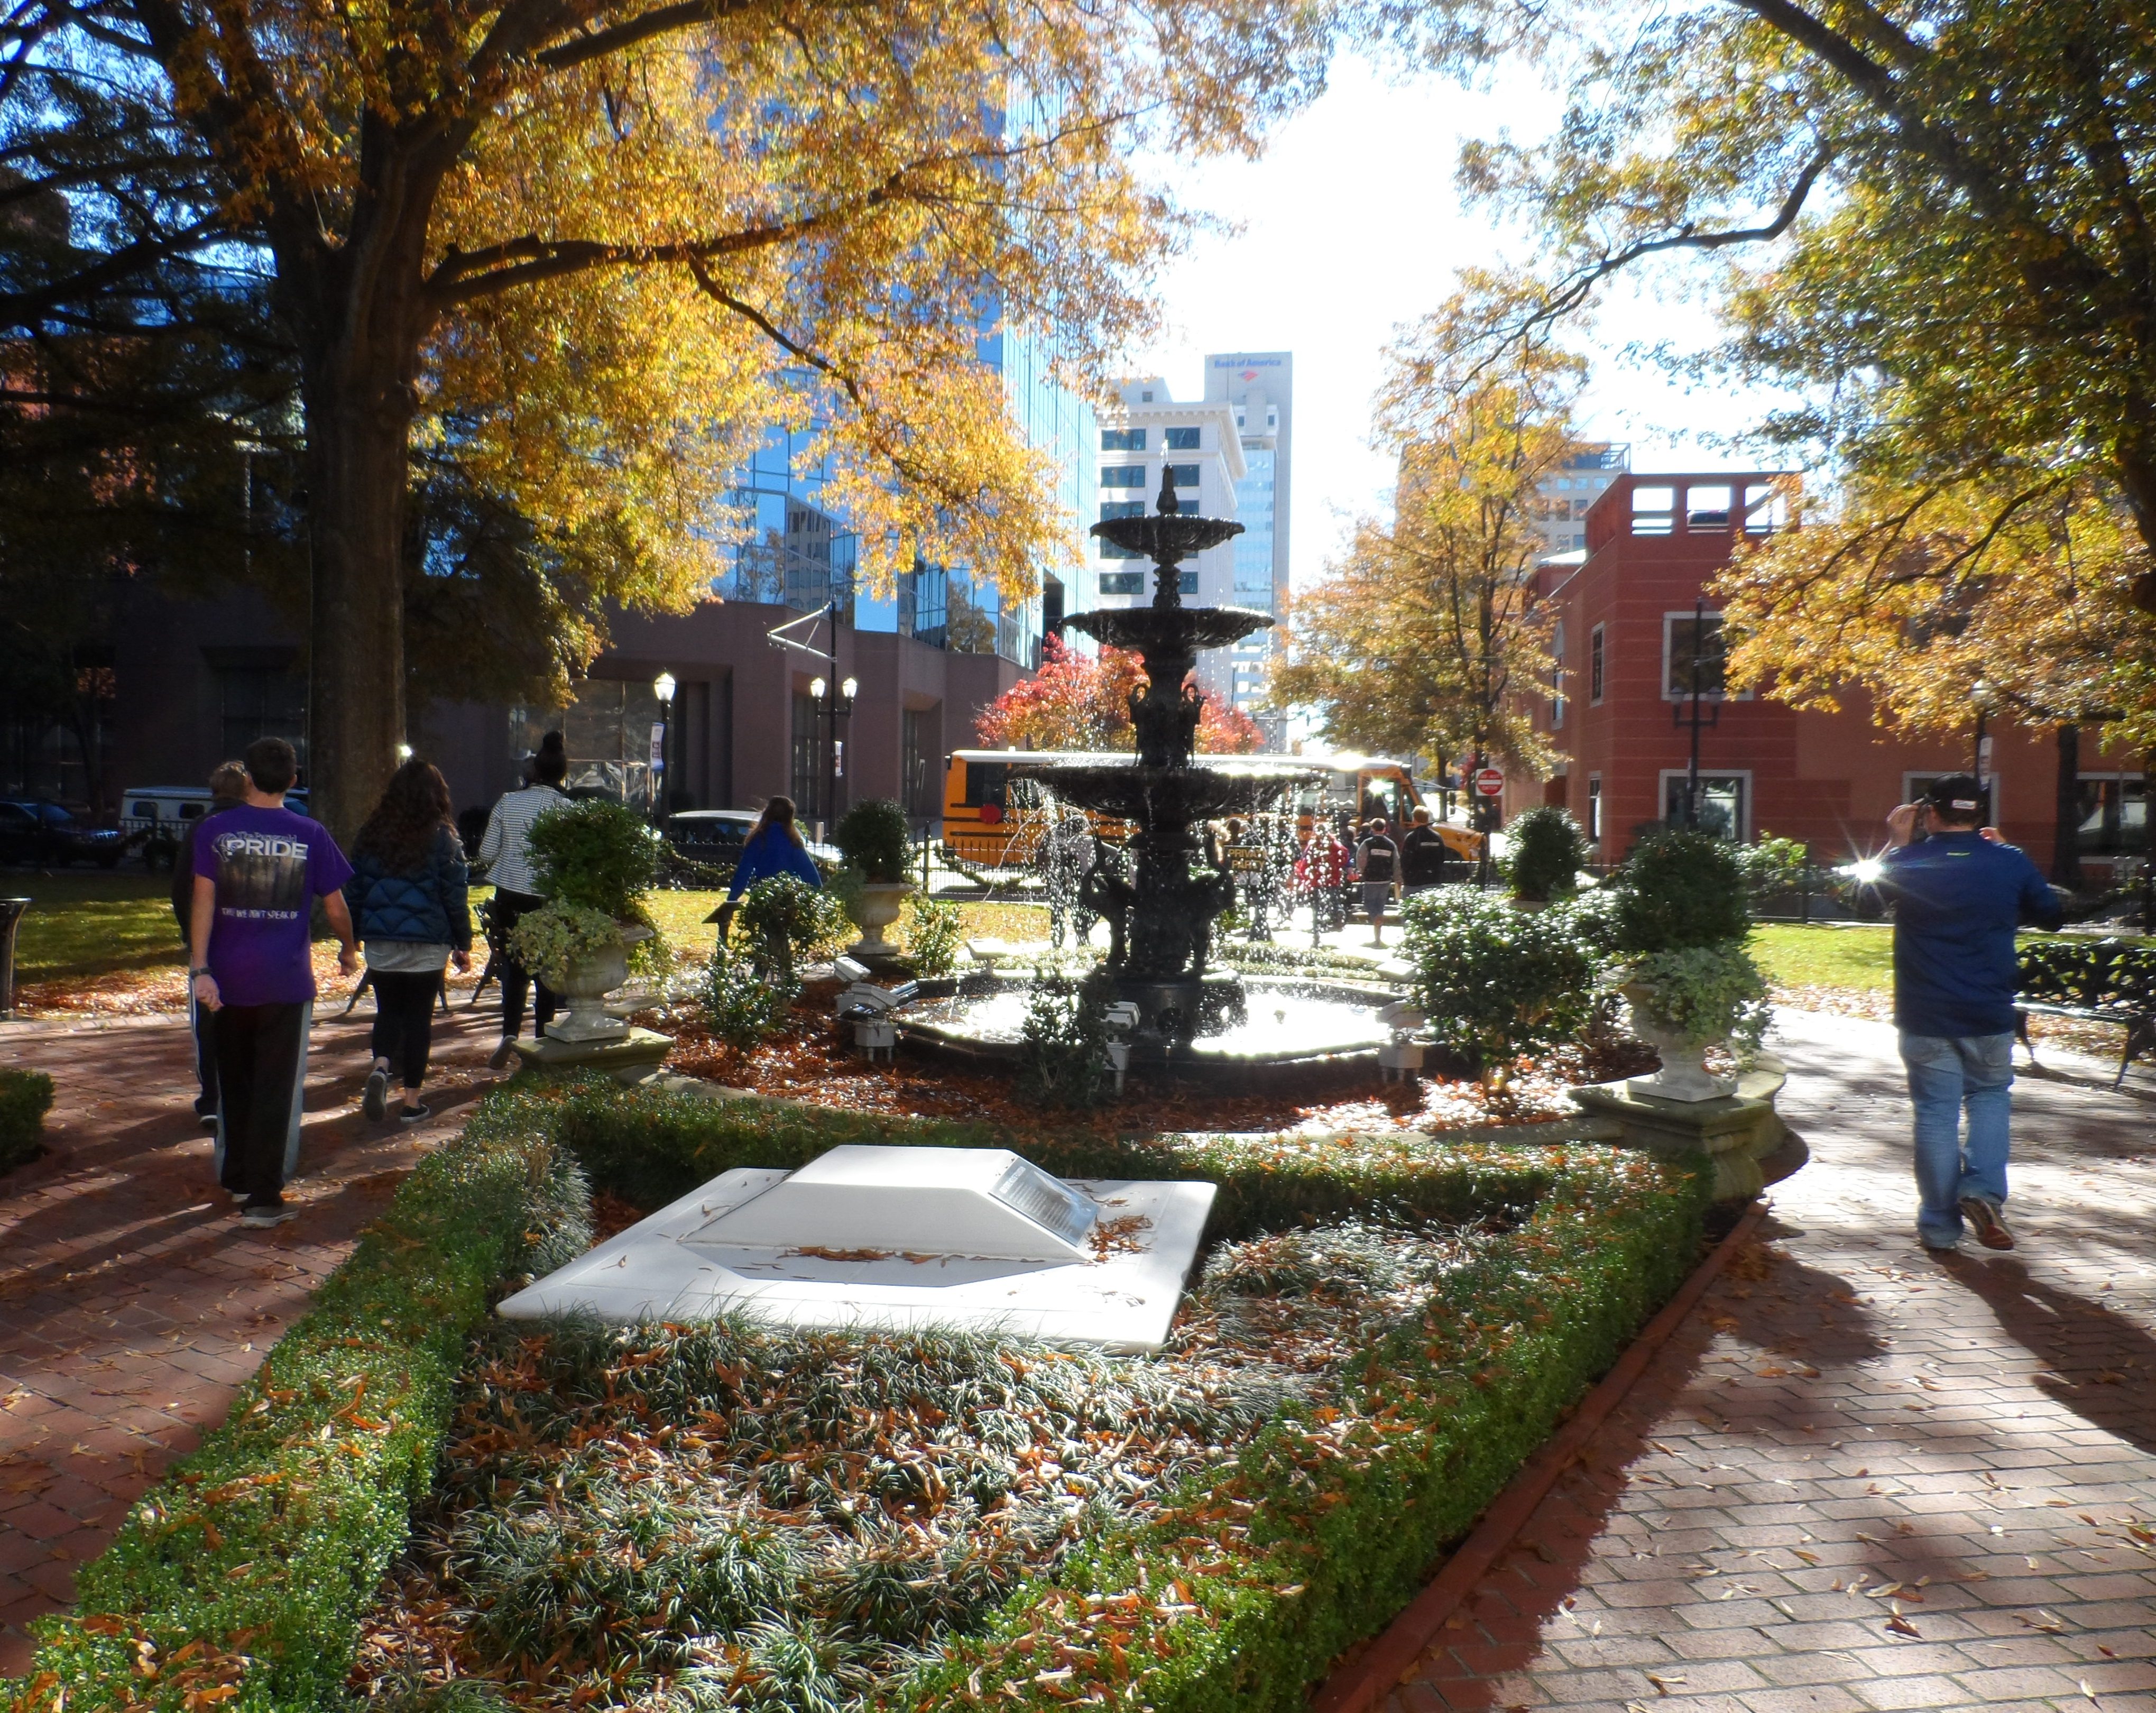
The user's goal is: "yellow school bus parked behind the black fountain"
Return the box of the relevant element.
[942,750,1481,868]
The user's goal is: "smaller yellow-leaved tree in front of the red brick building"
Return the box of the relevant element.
[1270,276,1580,771]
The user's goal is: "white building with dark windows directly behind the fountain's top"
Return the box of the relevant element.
[1086,375,1246,698]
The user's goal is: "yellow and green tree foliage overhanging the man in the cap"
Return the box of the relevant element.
[1390,0,2156,788]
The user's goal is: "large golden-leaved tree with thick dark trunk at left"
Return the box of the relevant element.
[0,0,1315,830]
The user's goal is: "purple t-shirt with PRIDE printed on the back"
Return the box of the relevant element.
[194,804,352,1006]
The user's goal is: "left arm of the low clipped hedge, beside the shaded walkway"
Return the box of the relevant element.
[11,1103,591,1713]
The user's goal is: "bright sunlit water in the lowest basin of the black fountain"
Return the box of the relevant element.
[897,976,1399,1077]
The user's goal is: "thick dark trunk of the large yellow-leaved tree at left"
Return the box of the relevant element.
[306,357,412,845]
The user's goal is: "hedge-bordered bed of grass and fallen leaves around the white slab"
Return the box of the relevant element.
[0,1082,1708,1713]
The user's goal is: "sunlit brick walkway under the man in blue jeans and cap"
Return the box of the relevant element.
[1384,1012,2156,1713]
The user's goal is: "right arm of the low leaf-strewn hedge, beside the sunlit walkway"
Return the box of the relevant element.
[882,1146,1708,1713]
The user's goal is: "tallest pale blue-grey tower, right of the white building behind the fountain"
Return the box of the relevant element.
[1205,351,1296,748]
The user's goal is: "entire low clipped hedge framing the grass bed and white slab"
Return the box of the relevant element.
[15,1084,1708,1713]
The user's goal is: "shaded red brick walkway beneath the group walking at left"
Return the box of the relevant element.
[0,1000,500,1677]
